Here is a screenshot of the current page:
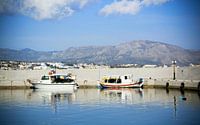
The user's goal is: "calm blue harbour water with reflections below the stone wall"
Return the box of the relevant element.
[0,89,200,125]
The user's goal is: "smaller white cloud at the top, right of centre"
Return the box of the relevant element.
[100,0,170,15]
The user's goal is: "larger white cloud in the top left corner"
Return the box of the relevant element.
[0,0,92,20]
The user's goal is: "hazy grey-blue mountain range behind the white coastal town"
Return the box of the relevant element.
[0,40,200,65]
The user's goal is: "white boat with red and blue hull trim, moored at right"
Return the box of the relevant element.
[98,75,144,88]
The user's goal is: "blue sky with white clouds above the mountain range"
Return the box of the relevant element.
[0,0,200,51]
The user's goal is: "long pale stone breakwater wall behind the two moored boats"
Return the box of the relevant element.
[0,66,200,90]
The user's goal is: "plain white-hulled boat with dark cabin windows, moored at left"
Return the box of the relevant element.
[30,72,78,90]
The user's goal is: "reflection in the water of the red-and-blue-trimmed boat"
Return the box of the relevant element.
[100,88,144,104]
